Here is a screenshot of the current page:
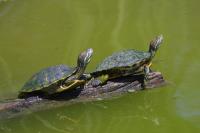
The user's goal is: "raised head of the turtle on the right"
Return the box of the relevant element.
[149,35,163,56]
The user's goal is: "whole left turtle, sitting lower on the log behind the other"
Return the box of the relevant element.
[18,48,93,98]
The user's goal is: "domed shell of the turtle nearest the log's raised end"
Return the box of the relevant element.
[96,50,151,72]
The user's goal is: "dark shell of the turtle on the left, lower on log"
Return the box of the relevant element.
[20,65,75,92]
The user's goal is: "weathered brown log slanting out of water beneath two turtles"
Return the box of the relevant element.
[0,72,166,119]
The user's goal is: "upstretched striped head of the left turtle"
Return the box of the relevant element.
[77,48,93,69]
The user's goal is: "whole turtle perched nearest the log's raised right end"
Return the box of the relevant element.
[88,35,163,86]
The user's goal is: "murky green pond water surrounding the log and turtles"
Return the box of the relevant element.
[0,0,200,133]
